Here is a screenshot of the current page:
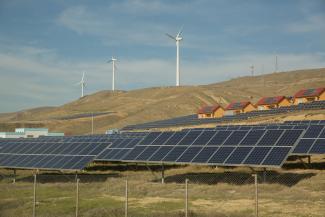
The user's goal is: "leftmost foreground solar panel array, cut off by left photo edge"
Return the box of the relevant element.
[0,136,111,170]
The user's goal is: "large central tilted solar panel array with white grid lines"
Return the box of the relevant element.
[107,129,304,167]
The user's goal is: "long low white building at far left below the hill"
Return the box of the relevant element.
[0,128,64,139]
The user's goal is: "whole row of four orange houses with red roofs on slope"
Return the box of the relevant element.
[198,88,325,118]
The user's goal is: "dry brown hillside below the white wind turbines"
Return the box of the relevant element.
[0,68,325,134]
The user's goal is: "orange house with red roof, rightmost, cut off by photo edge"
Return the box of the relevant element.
[293,88,325,105]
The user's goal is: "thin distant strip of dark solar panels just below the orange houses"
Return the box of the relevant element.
[123,101,325,130]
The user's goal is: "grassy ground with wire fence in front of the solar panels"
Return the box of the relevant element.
[0,165,325,217]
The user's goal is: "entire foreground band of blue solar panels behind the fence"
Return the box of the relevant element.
[0,123,325,169]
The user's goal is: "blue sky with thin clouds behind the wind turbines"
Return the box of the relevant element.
[0,0,325,112]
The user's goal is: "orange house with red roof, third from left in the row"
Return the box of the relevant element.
[256,96,291,110]
